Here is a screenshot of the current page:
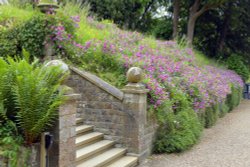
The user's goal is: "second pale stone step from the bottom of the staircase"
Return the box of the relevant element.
[77,148,126,167]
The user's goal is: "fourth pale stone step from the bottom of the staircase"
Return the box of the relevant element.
[75,132,103,147]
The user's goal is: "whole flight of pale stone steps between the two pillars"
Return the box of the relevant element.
[75,118,138,167]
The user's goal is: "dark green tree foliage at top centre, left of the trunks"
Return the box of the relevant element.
[87,0,152,30]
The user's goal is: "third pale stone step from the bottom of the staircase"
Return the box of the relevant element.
[76,140,114,161]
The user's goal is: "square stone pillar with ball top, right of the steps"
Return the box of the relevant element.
[123,67,150,161]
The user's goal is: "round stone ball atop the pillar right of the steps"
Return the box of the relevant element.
[127,67,143,83]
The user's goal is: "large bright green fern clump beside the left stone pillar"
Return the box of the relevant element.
[0,52,66,166]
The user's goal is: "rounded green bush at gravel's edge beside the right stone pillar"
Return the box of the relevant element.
[154,89,202,153]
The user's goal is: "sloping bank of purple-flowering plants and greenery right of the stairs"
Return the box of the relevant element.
[0,3,243,153]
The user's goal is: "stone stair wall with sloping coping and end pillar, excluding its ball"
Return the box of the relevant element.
[67,68,156,160]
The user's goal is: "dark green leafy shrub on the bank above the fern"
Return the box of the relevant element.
[0,7,75,58]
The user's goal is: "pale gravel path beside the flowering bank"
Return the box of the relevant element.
[139,100,250,167]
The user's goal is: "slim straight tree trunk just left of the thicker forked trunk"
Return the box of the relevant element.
[173,0,180,39]
